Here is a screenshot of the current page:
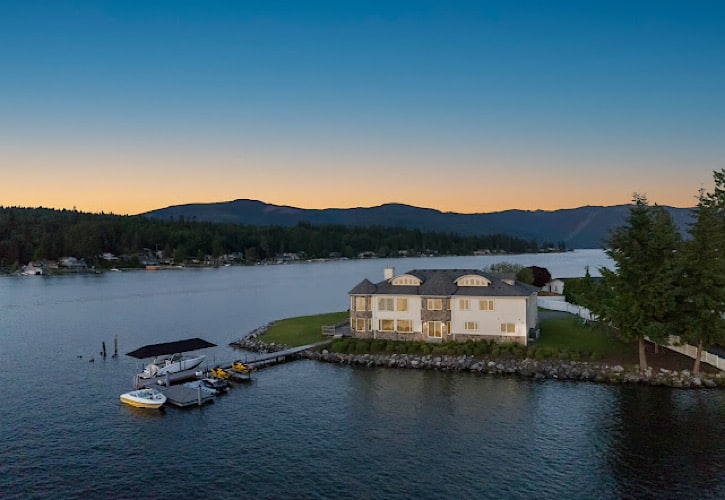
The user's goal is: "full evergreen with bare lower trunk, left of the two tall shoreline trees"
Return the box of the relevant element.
[593,194,680,372]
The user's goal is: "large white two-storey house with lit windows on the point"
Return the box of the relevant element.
[349,268,538,345]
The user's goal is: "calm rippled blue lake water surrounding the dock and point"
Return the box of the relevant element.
[0,251,725,498]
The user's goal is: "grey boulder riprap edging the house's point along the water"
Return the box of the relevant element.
[231,325,725,389]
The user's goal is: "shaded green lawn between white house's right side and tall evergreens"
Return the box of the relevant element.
[532,316,632,359]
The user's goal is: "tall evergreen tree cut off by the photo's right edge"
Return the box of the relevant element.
[678,169,725,374]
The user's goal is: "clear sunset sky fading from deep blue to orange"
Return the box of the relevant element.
[0,0,725,214]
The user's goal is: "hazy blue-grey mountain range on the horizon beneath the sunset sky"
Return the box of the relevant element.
[140,199,691,248]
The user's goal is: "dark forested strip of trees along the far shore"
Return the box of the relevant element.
[0,207,538,268]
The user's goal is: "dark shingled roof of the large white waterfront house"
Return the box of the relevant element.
[349,269,538,297]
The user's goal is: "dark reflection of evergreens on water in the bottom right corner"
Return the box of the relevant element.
[610,386,725,498]
